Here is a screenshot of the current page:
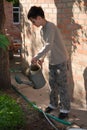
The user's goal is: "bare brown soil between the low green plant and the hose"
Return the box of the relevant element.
[5,89,58,130]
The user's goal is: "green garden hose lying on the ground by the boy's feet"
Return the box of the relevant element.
[12,85,72,126]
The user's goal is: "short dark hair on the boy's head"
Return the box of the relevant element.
[27,6,45,19]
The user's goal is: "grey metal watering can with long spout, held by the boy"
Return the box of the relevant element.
[15,64,46,89]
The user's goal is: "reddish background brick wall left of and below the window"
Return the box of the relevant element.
[4,0,21,41]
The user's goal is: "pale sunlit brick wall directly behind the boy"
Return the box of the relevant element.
[20,0,87,108]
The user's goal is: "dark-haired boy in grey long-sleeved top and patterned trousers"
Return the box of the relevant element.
[27,6,70,119]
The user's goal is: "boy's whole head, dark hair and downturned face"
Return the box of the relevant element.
[27,6,45,27]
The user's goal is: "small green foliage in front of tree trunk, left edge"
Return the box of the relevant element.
[0,34,10,50]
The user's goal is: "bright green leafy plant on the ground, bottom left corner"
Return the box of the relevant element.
[0,94,25,130]
